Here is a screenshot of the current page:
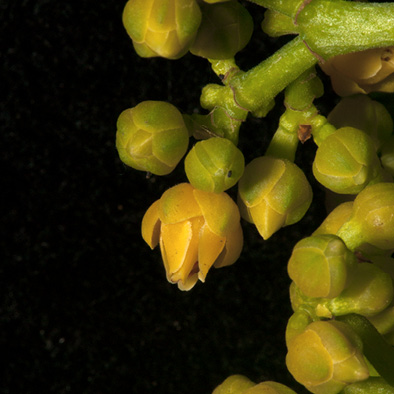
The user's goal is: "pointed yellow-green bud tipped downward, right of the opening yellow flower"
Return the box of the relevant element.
[238,156,312,239]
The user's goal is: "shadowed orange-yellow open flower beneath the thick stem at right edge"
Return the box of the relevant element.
[320,47,394,96]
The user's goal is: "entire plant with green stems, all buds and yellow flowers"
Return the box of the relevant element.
[116,0,394,394]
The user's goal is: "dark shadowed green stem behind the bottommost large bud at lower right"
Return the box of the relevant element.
[337,314,394,386]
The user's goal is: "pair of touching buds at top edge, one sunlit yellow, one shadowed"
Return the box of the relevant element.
[123,0,253,59]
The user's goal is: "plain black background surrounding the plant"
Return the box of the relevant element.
[0,0,350,394]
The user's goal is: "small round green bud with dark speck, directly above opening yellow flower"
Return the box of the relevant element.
[185,137,245,193]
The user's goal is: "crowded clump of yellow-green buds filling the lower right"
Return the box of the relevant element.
[286,182,394,394]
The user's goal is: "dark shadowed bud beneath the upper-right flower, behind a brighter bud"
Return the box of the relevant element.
[327,94,393,150]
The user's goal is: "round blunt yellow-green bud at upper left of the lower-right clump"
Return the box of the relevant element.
[287,234,357,298]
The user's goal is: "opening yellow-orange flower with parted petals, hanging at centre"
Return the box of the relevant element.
[141,183,243,290]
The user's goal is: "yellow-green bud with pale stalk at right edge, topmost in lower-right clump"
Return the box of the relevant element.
[337,182,394,250]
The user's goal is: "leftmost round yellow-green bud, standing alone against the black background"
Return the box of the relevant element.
[116,101,189,175]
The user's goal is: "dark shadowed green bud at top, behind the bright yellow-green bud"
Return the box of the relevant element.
[190,1,253,59]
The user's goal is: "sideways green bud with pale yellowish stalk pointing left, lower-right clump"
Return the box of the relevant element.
[327,263,394,316]
